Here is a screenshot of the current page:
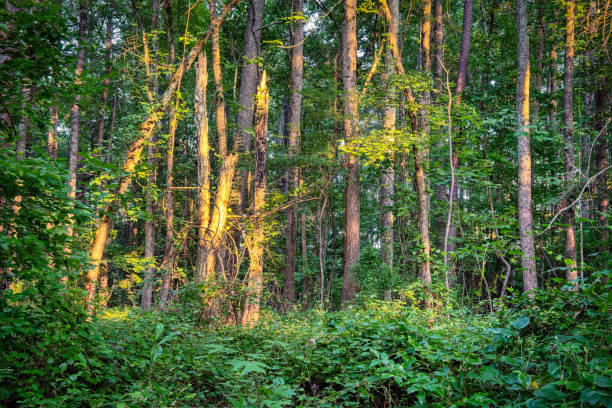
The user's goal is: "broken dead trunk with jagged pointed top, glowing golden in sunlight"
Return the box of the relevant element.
[242,71,268,326]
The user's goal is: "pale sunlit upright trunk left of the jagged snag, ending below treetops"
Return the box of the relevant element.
[195,54,213,282]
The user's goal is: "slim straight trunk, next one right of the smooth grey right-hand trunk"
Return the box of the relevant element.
[561,0,578,290]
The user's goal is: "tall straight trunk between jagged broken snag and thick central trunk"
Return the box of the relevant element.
[283,0,304,307]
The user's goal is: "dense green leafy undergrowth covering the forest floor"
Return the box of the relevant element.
[0,276,612,407]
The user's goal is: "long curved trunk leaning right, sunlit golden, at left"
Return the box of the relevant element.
[85,0,240,311]
